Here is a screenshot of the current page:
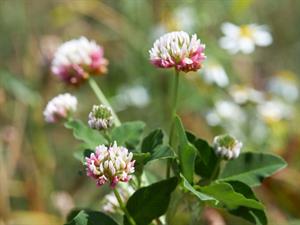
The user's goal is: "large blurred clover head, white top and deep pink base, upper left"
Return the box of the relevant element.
[51,37,108,85]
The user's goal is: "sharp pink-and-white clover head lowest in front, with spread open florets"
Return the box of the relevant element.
[85,142,135,188]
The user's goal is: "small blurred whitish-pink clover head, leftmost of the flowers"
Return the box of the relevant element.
[44,93,77,123]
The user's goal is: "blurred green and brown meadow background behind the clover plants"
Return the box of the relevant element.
[0,0,300,225]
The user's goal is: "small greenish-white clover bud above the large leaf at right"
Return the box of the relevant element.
[213,134,243,160]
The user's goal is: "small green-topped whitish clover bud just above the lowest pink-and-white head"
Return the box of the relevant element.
[88,105,114,130]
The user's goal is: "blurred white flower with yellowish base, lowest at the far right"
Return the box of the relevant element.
[257,100,292,123]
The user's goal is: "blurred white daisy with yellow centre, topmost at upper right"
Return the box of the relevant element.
[220,22,273,54]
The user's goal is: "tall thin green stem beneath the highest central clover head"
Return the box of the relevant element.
[166,69,179,178]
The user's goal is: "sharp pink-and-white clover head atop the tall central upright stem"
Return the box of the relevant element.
[149,31,206,72]
